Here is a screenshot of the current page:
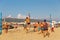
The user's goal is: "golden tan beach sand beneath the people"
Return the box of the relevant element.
[0,27,60,40]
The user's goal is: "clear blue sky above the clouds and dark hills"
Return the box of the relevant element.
[0,0,60,19]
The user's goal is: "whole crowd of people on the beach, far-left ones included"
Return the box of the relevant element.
[3,17,54,37]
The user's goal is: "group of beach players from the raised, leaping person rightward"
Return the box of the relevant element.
[24,17,54,37]
